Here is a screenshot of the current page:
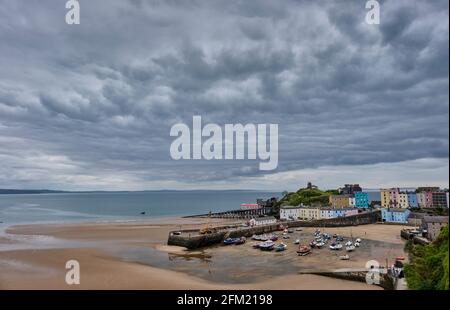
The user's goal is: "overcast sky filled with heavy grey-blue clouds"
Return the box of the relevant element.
[0,0,449,190]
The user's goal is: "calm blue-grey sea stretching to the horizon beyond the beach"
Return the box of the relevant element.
[0,191,281,226]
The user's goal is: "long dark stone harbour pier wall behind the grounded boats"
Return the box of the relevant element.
[167,211,381,249]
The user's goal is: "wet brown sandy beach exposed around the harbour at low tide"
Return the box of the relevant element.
[0,218,404,290]
